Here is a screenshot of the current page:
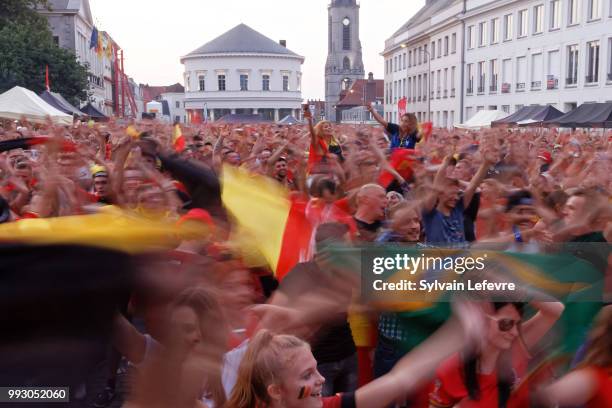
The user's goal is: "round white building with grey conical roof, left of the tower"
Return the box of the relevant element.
[181,24,304,122]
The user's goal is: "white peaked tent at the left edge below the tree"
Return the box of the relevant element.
[0,86,72,125]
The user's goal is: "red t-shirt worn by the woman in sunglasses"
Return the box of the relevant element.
[429,347,529,408]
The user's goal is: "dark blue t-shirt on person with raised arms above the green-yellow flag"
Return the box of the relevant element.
[423,196,466,244]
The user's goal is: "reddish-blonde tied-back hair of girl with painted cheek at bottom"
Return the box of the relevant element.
[227,330,308,408]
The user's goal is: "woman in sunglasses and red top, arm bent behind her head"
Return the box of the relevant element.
[430,302,564,408]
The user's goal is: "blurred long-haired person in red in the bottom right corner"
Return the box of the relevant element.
[540,305,612,408]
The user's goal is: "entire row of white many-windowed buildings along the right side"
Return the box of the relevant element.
[383,0,612,126]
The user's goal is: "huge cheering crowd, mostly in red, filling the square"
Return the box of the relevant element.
[0,109,612,408]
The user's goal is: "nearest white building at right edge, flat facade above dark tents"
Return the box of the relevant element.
[464,0,612,120]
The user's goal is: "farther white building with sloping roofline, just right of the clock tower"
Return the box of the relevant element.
[382,0,462,127]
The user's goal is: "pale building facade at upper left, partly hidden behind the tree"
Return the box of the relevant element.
[37,0,107,112]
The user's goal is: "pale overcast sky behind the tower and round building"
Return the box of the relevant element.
[90,0,425,99]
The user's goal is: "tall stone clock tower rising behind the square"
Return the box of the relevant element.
[325,0,365,122]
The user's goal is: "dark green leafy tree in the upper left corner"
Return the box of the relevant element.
[0,0,88,104]
